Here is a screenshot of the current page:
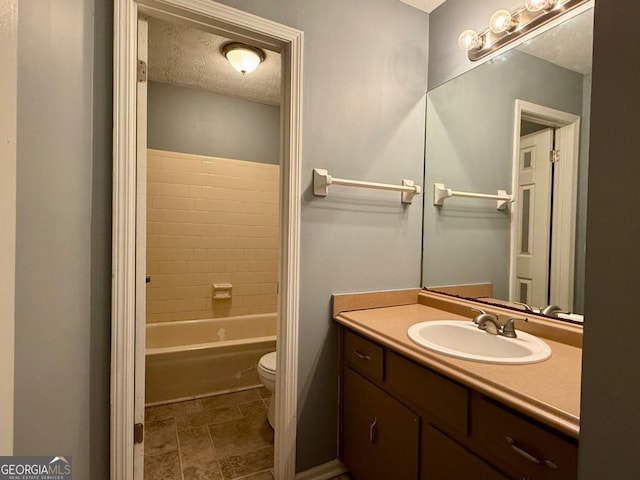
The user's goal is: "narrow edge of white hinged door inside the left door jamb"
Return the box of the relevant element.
[133,17,148,480]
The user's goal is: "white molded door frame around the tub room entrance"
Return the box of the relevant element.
[110,0,303,480]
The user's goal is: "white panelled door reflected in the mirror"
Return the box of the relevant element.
[515,128,553,307]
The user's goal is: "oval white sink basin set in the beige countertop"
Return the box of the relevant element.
[407,320,551,364]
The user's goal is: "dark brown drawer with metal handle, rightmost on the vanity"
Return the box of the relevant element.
[471,396,578,480]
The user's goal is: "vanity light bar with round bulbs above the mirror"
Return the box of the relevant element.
[458,0,590,62]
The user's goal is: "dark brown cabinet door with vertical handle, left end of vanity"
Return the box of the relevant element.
[342,368,420,480]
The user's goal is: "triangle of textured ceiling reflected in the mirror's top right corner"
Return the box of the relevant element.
[518,8,593,75]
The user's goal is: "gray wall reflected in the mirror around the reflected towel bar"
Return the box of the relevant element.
[422,51,583,299]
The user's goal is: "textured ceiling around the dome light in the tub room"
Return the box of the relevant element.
[149,18,282,105]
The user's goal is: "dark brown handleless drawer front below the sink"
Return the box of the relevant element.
[385,352,469,435]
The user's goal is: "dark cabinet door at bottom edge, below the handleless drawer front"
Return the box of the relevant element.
[421,425,508,480]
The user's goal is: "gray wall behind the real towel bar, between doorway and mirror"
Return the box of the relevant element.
[212,0,428,470]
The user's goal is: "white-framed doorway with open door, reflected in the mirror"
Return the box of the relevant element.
[509,100,580,311]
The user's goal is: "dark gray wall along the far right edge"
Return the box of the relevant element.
[579,0,640,480]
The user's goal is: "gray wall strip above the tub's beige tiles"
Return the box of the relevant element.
[148,82,280,164]
